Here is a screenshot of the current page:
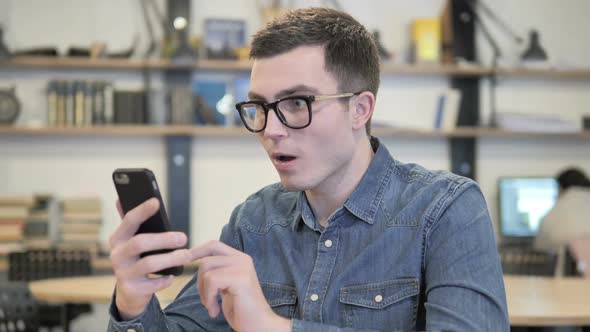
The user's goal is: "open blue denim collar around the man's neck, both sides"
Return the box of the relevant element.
[294,137,395,231]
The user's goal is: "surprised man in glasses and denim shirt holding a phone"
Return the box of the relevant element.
[109,8,508,331]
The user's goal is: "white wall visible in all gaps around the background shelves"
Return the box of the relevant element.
[0,0,590,244]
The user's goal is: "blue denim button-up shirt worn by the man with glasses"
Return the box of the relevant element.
[108,138,509,331]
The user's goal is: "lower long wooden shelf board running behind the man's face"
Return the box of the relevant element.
[0,125,590,139]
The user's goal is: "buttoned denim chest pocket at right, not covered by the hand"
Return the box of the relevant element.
[340,278,420,330]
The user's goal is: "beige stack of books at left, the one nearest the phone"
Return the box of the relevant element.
[59,197,102,252]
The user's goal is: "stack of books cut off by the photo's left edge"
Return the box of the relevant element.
[0,195,33,262]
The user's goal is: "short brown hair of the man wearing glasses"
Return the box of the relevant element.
[250,7,380,134]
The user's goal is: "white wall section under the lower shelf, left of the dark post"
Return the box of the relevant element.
[0,136,167,246]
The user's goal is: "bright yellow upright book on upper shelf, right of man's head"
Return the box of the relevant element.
[412,17,441,63]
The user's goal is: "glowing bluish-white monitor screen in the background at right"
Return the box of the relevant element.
[498,177,559,238]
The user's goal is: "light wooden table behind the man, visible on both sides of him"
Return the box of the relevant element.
[30,275,590,326]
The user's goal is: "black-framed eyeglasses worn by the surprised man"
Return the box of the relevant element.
[236,91,362,133]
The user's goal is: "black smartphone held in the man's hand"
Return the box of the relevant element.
[113,168,183,275]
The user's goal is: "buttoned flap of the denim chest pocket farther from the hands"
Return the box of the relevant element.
[340,278,420,309]
